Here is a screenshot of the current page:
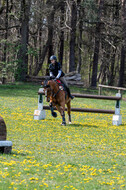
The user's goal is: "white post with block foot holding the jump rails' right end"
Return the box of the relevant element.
[112,93,122,126]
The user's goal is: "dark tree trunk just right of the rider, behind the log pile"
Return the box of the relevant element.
[69,1,77,72]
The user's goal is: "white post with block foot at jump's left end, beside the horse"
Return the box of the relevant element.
[34,88,46,120]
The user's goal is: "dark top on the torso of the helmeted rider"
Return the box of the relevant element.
[49,62,65,77]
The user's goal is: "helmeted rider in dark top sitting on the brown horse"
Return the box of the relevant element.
[49,55,74,99]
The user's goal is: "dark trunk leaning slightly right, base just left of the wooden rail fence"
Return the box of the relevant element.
[91,0,104,87]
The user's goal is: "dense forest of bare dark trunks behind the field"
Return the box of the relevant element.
[0,0,126,87]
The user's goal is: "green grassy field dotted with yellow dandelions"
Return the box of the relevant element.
[0,84,126,190]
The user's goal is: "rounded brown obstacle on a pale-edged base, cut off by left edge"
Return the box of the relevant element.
[0,117,12,154]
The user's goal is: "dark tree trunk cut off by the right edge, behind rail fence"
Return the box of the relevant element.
[118,0,126,86]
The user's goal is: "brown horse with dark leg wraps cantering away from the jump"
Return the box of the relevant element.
[42,79,71,125]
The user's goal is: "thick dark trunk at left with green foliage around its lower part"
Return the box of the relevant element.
[16,0,31,81]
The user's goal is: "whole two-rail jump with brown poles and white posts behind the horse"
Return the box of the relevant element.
[34,88,122,126]
